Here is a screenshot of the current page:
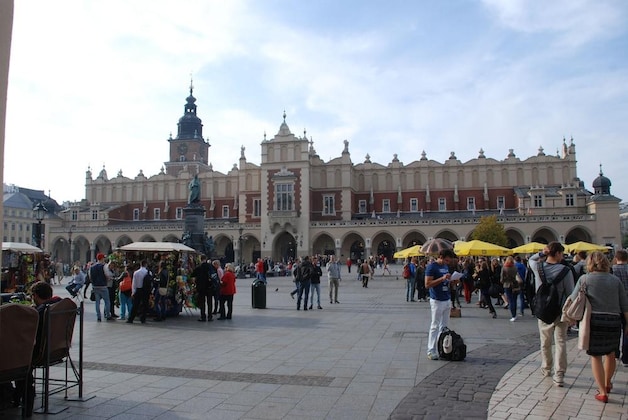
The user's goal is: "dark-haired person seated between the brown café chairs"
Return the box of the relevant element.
[13,281,61,417]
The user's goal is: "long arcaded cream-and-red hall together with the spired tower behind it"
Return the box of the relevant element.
[46,87,621,262]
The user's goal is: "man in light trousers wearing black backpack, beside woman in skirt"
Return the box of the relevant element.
[529,242,574,387]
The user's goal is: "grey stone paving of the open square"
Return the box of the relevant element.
[0,268,628,419]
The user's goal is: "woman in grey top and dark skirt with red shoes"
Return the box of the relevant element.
[571,251,628,403]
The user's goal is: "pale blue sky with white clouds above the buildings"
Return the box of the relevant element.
[4,0,628,202]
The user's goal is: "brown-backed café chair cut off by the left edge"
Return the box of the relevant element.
[0,303,39,417]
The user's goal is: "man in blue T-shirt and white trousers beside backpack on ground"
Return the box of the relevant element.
[425,249,457,360]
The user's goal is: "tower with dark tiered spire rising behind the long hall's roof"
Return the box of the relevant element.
[165,81,210,176]
